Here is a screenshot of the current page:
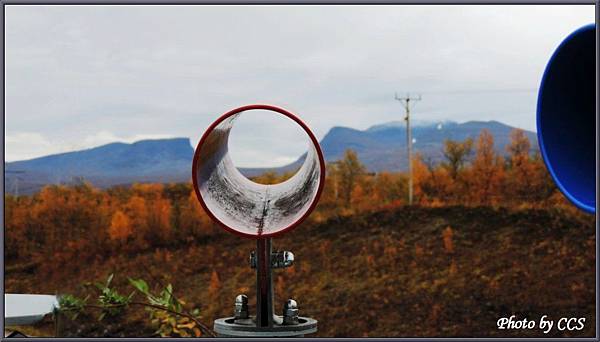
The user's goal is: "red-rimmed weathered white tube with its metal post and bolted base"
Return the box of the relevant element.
[192,104,325,338]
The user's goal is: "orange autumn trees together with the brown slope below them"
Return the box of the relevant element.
[5,130,596,337]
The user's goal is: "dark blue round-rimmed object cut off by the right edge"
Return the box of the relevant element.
[537,24,597,213]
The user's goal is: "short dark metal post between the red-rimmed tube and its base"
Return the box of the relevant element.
[256,238,273,327]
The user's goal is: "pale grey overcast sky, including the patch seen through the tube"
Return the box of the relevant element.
[5,5,594,166]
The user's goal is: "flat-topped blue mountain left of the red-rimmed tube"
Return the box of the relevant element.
[5,138,194,193]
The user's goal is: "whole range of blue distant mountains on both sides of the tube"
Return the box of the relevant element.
[5,121,538,194]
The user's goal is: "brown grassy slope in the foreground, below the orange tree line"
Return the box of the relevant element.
[6,207,595,337]
